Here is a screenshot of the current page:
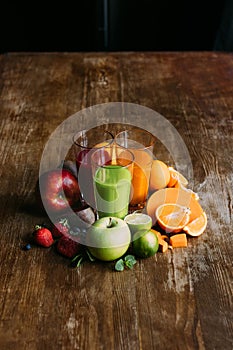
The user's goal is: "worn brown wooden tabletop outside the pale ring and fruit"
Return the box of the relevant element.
[0,52,233,350]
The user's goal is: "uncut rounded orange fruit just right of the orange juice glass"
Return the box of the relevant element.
[150,159,170,191]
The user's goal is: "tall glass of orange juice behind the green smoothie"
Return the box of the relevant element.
[115,127,156,212]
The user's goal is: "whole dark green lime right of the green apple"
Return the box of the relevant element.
[132,230,159,258]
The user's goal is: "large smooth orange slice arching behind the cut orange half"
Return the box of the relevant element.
[146,188,203,226]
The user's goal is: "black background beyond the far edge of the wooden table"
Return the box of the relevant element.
[0,0,233,53]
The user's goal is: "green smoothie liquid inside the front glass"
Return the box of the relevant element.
[94,165,131,219]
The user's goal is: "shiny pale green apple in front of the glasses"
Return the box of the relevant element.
[86,217,131,261]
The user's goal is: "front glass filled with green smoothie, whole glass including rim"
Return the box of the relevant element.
[91,146,134,219]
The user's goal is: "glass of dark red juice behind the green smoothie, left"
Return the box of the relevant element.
[73,125,114,208]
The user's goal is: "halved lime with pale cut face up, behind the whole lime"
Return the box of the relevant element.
[124,213,152,235]
